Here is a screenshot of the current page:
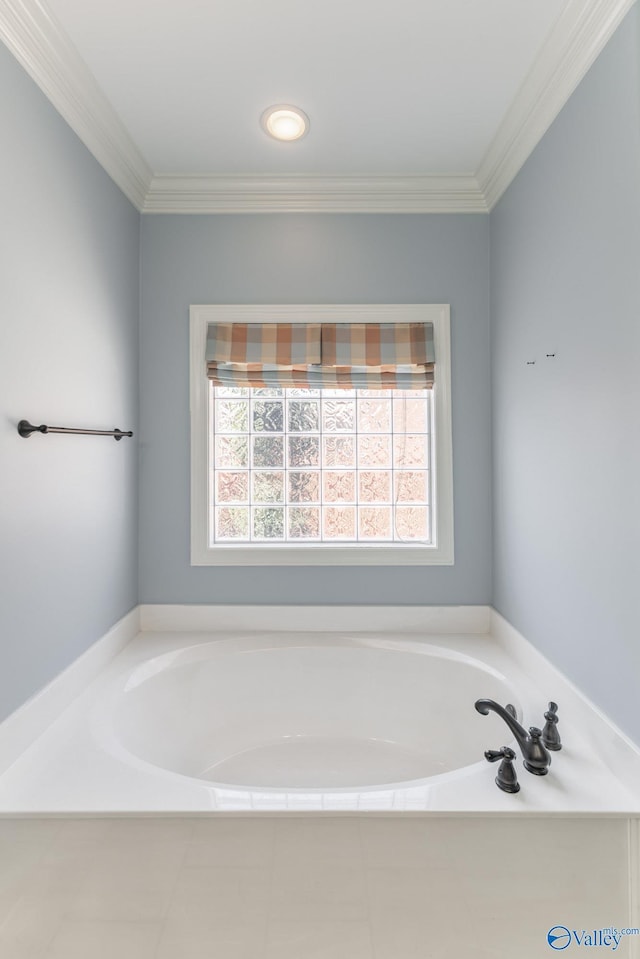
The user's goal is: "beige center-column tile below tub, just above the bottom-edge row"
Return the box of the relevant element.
[270,863,368,921]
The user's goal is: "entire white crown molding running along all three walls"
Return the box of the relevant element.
[0,0,636,214]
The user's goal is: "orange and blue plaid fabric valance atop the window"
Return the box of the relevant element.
[207,323,435,390]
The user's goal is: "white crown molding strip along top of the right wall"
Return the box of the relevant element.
[477,0,636,210]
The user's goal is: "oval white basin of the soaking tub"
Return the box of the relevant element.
[113,636,517,791]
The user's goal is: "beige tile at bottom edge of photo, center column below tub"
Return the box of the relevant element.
[264,920,373,959]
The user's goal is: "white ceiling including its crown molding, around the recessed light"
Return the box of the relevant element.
[0,0,634,212]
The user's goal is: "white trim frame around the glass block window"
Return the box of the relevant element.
[189,304,454,566]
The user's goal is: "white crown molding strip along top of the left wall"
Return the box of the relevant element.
[0,0,152,209]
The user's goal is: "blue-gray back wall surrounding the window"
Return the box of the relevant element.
[140,215,491,604]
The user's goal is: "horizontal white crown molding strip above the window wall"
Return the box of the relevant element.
[142,175,487,213]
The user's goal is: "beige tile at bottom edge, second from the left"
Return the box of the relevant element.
[44,920,162,959]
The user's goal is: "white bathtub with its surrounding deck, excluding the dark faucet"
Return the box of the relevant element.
[0,612,640,815]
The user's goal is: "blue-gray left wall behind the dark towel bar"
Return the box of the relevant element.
[0,44,139,719]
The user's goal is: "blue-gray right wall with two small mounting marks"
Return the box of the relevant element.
[491,6,640,741]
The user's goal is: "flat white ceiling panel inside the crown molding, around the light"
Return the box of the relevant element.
[43,0,565,175]
